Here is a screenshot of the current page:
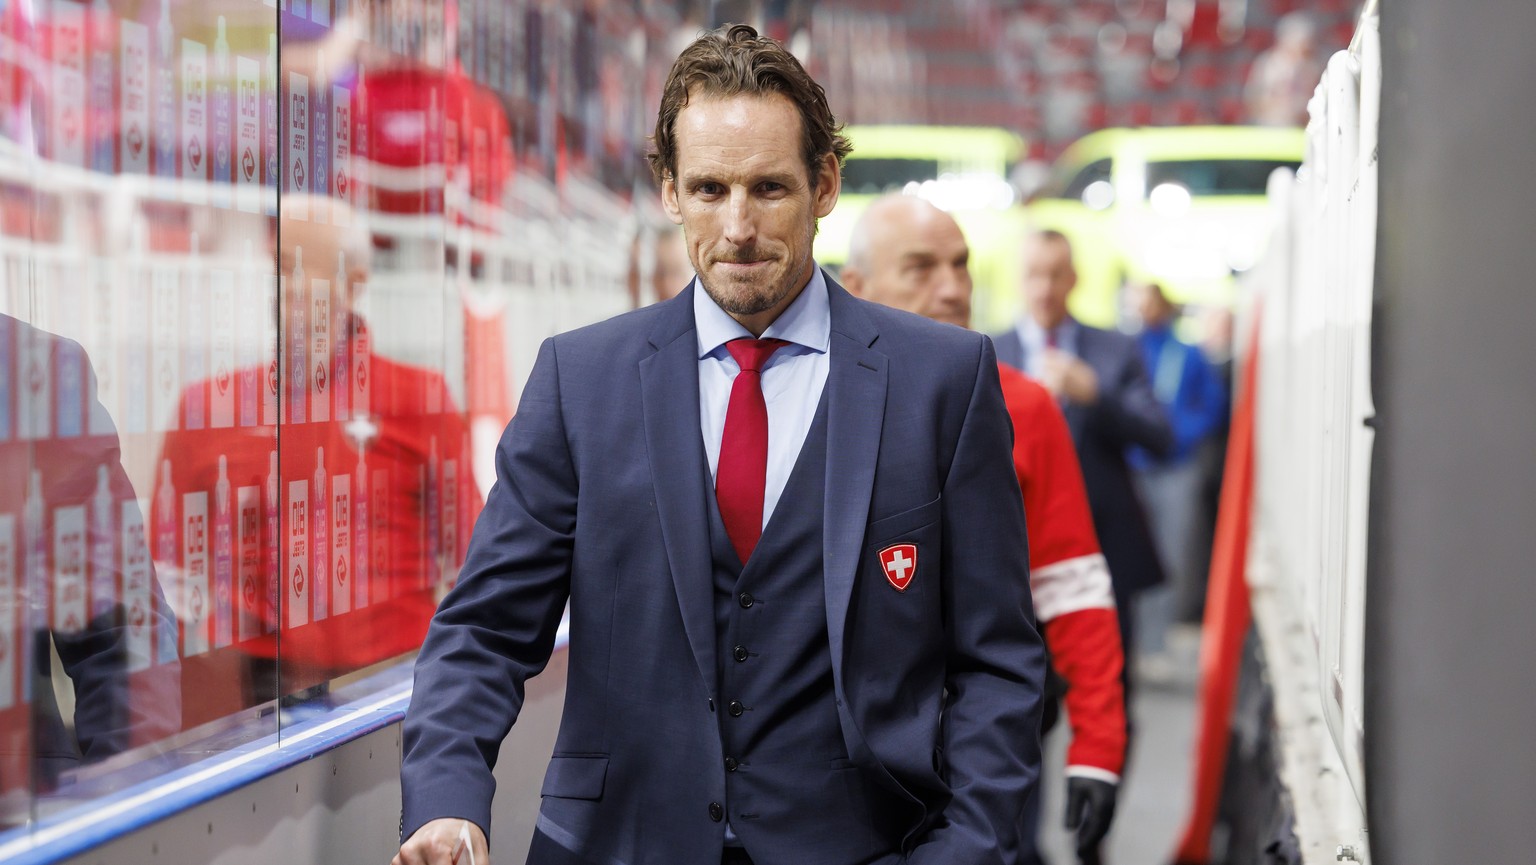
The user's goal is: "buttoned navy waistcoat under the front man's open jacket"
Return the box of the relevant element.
[710,393,903,863]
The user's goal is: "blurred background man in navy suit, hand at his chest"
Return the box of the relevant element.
[994,230,1174,673]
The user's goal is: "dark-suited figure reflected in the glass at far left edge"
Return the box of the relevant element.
[0,316,181,825]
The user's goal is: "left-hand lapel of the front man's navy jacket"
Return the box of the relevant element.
[641,289,714,696]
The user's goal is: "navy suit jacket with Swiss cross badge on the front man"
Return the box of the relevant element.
[401,278,1044,865]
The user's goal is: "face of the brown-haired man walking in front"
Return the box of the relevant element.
[662,94,840,326]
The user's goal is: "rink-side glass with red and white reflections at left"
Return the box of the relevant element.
[0,0,685,828]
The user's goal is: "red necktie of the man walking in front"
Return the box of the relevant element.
[714,336,788,564]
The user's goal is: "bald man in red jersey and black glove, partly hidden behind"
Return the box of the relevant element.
[842,195,1126,862]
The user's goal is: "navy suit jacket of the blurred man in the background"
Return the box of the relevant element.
[994,323,1174,601]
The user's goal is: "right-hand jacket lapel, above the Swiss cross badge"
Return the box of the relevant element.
[822,277,889,679]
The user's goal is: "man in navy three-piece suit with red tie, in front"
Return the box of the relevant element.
[396,26,1044,865]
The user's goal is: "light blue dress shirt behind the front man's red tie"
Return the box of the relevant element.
[693,267,833,527]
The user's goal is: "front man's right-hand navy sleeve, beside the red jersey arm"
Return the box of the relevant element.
[909,340,1044,865]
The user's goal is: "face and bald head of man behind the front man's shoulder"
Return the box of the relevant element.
[859,198,971,327]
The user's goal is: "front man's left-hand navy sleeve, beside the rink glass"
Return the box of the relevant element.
[401,340,576,839]
